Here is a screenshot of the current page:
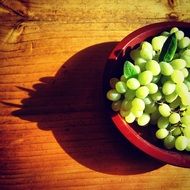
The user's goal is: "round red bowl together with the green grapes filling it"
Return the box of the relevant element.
[104,22,190,167]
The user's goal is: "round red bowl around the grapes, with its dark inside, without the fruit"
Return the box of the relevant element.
[103,22,190,168]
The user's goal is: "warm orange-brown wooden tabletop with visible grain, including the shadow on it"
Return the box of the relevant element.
[0,0,190,190]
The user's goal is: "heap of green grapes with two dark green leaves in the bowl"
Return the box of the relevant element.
[107,27,190,151]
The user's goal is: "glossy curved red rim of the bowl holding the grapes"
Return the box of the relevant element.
[104,21,190,168]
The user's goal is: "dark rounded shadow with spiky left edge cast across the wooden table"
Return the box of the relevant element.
[4,42,163,175]
